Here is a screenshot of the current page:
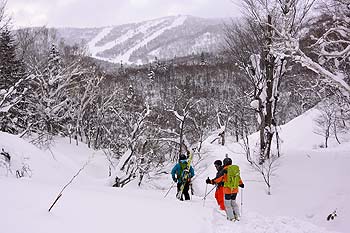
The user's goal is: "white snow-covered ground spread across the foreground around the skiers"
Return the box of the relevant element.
[0,110,350,233]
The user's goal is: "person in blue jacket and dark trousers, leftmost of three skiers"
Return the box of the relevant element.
[171,154,194,201]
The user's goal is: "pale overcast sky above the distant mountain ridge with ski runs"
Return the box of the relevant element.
[7,0,239,27]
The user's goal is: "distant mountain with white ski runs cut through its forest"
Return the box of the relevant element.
[57,15,227,64]
